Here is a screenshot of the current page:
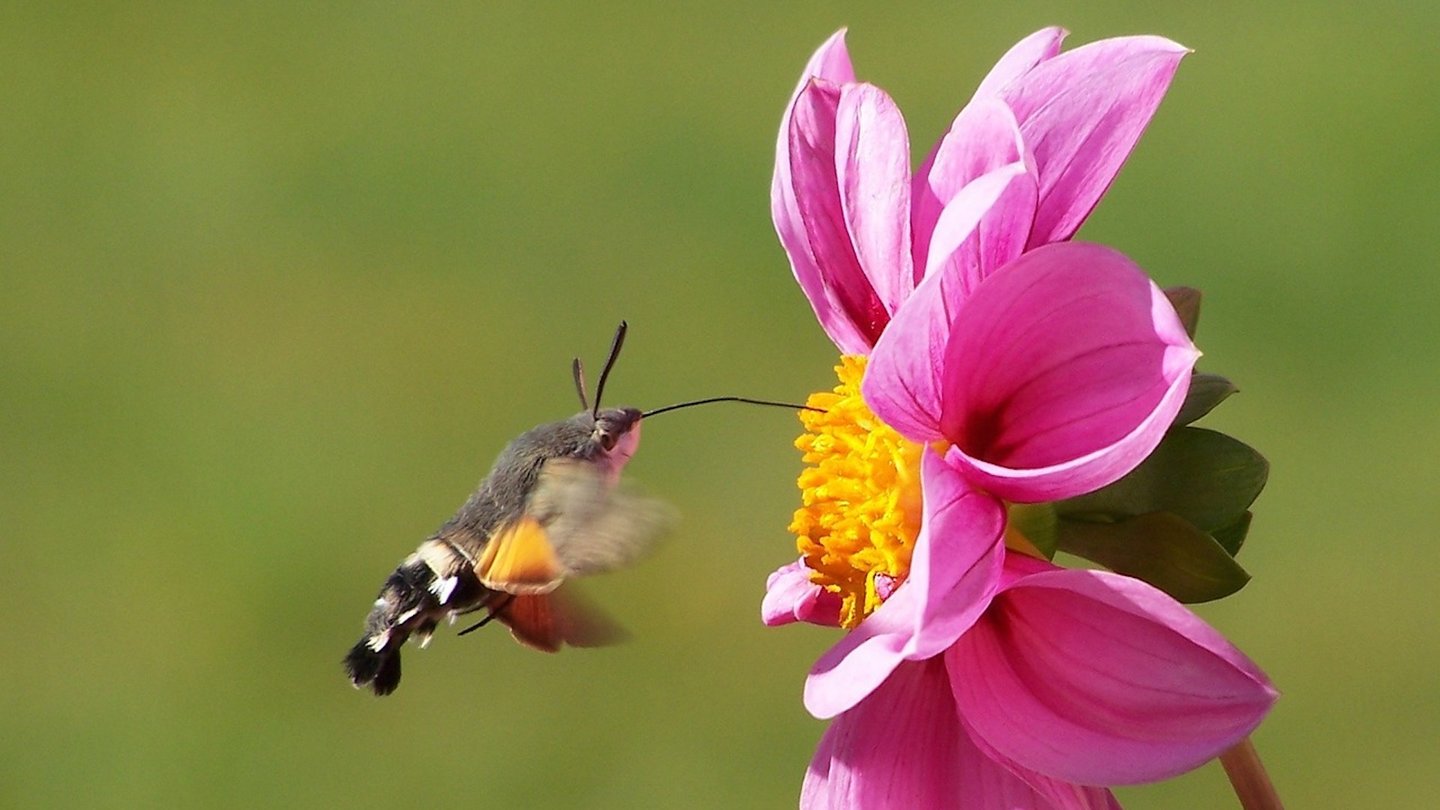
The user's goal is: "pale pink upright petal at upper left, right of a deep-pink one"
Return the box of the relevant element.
[835,84,914,313]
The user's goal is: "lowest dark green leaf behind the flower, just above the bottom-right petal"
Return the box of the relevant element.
[1060,512,1250,602]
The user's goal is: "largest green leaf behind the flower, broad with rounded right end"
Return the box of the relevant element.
[1056,428,1270,532]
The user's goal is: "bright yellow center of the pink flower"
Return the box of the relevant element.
[791,356,922,628]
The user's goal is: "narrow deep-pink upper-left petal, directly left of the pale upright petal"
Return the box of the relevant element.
[789,79,890,353]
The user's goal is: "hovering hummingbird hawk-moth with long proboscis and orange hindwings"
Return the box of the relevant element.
[344,321,796,695]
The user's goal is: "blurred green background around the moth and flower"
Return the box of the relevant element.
[0,1,1440,807]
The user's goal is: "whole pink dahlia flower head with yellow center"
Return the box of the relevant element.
[762,30,1276,807]
